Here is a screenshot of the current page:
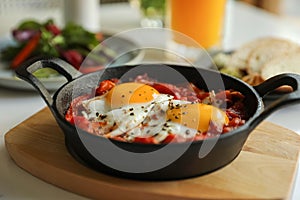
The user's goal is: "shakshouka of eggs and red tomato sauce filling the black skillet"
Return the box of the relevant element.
[65,74,247,144]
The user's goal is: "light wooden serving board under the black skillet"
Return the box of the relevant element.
[5,108,300,200]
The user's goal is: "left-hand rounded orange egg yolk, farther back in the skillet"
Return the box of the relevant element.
[106,82,159,109]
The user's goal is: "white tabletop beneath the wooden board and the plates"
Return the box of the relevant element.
[0,2,300,200]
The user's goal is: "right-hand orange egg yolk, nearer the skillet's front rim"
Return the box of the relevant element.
[167,104,229,133]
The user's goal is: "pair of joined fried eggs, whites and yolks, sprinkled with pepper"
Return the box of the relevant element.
[83,82,229,143]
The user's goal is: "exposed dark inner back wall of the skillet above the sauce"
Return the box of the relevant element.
[54,64,260,141]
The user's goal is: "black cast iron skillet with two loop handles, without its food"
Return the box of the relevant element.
[16,59,300,180]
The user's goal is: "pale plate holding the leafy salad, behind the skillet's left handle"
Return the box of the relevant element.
[0,35,144,91]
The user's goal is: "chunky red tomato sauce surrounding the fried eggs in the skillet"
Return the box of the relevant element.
[65,74,247,144]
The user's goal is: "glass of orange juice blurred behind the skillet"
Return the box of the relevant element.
[169,0,226,49]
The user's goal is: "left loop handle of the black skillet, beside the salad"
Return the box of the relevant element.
[16,58,82,108]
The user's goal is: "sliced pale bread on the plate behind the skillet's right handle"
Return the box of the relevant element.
[214,37,300,92]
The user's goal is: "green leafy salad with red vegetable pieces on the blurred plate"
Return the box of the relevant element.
[0,19,117,78]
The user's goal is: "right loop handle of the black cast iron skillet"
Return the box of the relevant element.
[250,73,300,128]
